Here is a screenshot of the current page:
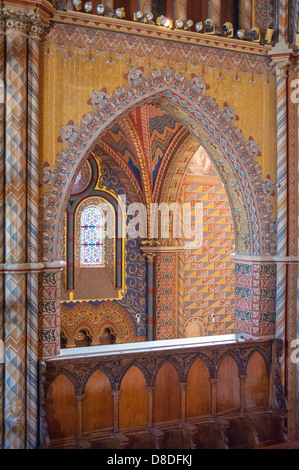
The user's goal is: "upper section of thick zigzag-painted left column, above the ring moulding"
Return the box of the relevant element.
[5,35,27,263]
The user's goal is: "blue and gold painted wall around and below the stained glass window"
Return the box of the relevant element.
[61,159,146,346]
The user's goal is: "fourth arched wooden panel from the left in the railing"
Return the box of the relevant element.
[153,362,181,423]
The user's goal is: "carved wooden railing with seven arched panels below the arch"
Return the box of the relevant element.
[40,339,286,448]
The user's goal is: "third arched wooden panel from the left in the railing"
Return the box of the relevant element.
[119,366,148,429]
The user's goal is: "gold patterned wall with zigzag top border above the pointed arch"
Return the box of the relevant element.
[40,23,276,189]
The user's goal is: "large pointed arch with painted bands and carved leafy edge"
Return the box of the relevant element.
[42,67,276,261]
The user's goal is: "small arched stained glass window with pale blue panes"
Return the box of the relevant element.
[80,206,104,266]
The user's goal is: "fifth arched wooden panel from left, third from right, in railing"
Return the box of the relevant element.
[186,359,211,418]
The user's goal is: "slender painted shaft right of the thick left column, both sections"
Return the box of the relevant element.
[26,37,39,449]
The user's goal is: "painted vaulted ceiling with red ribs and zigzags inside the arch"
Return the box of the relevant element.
[98,104,198,200]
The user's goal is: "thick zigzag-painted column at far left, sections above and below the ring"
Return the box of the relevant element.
[4,34,27,449]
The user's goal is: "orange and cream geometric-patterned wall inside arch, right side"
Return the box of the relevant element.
[183,184,235,335]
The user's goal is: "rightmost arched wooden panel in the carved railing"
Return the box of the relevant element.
[245,353,269,408]
